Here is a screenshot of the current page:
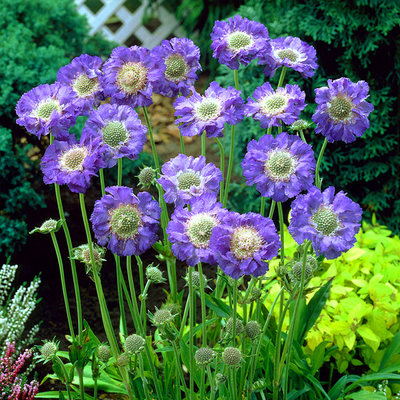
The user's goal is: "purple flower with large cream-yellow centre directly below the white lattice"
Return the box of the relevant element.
[101,46,159,108]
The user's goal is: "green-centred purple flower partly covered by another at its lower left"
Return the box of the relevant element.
[82,104,147,168]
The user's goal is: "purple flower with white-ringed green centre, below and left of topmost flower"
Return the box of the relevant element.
[174,82,244,138]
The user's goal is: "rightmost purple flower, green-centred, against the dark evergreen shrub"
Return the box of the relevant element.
[312,78,374,143]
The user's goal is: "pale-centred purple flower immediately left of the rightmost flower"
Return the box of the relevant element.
[244,82,306,128]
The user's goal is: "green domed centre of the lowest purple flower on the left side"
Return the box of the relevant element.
[110,204,142,239]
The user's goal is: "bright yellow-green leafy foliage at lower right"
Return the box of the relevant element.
[265,217,400,372]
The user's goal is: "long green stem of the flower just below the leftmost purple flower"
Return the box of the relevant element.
[79,193,134,400]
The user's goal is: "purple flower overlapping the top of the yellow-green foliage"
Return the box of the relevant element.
[289,186,362,259]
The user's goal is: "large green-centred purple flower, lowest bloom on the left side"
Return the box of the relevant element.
[90,186,161,256]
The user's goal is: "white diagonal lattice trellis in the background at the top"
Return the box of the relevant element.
[75,0,183,49]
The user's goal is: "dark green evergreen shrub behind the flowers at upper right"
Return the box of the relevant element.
[218,0,400,232]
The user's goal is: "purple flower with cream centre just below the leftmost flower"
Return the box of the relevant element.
[41,135,105,193]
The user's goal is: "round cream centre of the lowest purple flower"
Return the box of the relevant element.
[230,226,263,260]
